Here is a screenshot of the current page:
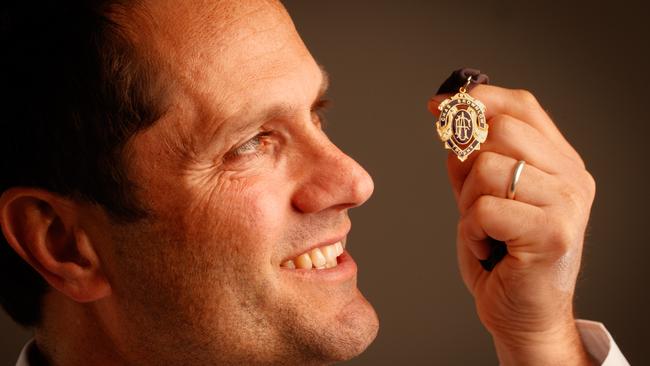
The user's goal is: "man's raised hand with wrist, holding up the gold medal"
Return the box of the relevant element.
[429,85,595,365]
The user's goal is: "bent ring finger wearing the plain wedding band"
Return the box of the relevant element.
[458,152,562,215]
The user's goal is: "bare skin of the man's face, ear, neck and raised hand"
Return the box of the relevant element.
[0,0,595,365]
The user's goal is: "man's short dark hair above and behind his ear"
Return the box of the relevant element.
[0,0,164,326]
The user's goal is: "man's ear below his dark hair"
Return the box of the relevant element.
[0,187,111,302]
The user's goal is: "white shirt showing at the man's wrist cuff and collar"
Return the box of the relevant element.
[16,320,630,366]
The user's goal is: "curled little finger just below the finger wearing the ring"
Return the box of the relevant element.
[458,196,551,260]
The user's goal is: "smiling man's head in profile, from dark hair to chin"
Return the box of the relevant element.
[1,1,378,365]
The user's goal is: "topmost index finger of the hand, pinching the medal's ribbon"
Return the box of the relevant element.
[428,85,584,165]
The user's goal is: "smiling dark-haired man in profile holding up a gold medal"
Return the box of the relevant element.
[0,0,628,365]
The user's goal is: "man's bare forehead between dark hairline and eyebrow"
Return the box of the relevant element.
[124,0,321,115]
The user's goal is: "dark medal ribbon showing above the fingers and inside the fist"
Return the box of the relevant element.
[436,68,508,272]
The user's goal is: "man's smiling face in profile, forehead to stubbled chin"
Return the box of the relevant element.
[92,1,378,365]
